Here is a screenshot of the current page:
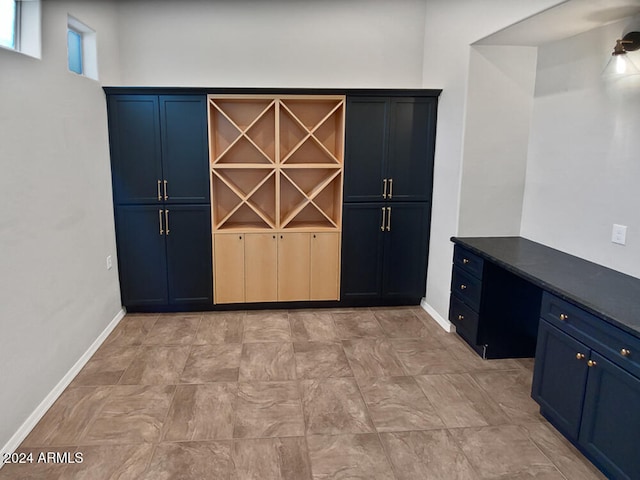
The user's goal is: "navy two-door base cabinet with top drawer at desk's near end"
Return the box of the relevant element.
[532,293,640,480]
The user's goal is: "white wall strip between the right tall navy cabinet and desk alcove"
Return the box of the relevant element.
[422,0,562,319]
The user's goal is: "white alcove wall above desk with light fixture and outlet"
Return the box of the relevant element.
[522,20,640,277]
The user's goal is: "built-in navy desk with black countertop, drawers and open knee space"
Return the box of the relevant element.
[449,237,640,479]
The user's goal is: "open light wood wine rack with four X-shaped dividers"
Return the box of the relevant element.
[209,95,345,232]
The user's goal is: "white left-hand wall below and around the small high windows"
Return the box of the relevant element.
[0,1,121,447]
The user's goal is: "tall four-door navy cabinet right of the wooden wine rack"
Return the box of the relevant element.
[341,95,437,304]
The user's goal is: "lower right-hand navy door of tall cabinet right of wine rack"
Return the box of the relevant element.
[382,202,430,300]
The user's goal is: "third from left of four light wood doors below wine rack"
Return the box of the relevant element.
[278,233,311,302]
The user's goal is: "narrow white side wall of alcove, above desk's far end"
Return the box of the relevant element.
[458,46,537,237]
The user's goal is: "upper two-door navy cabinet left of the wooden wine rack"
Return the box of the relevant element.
[108,95,209,204]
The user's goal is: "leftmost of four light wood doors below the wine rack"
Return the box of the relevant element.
[213,233,245,303]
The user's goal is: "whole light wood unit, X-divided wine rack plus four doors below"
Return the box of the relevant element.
[208,95,345,303]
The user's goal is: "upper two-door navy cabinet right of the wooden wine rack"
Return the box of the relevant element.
[344,96,437,202]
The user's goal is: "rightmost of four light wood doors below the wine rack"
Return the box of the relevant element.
[310,232,340,300]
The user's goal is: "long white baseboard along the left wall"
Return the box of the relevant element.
[0,308,126,462]
